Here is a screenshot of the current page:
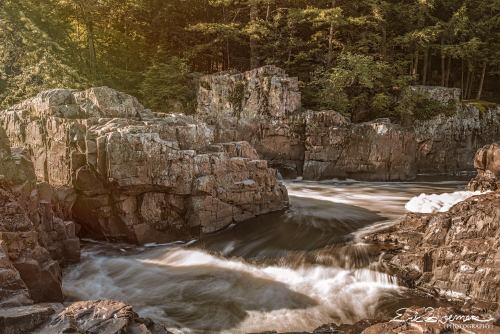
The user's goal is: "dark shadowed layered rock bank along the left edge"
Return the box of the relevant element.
[0,129,80,305]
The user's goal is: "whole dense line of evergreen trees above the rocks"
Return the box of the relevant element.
[0,0,500,120]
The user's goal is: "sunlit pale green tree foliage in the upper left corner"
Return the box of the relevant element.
[0,0,86,107]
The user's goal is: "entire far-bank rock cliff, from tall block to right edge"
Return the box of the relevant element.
[197,66,500,181]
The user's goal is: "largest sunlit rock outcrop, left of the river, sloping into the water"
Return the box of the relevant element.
[0,87,288,243]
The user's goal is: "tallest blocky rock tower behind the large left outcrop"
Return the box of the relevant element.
[197,66,304,177]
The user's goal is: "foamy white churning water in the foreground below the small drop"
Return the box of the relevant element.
[64,247,400,333]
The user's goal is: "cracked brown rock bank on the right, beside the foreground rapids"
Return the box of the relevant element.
[369,192,500,313]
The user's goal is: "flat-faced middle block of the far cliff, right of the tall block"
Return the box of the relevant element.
[304,111,416,181]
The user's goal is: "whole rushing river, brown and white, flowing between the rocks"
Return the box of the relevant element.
[64,181,464,333]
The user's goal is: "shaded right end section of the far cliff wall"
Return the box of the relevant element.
[415,106,500,173]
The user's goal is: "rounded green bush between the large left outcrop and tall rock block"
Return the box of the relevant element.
[140,57,195,113]
